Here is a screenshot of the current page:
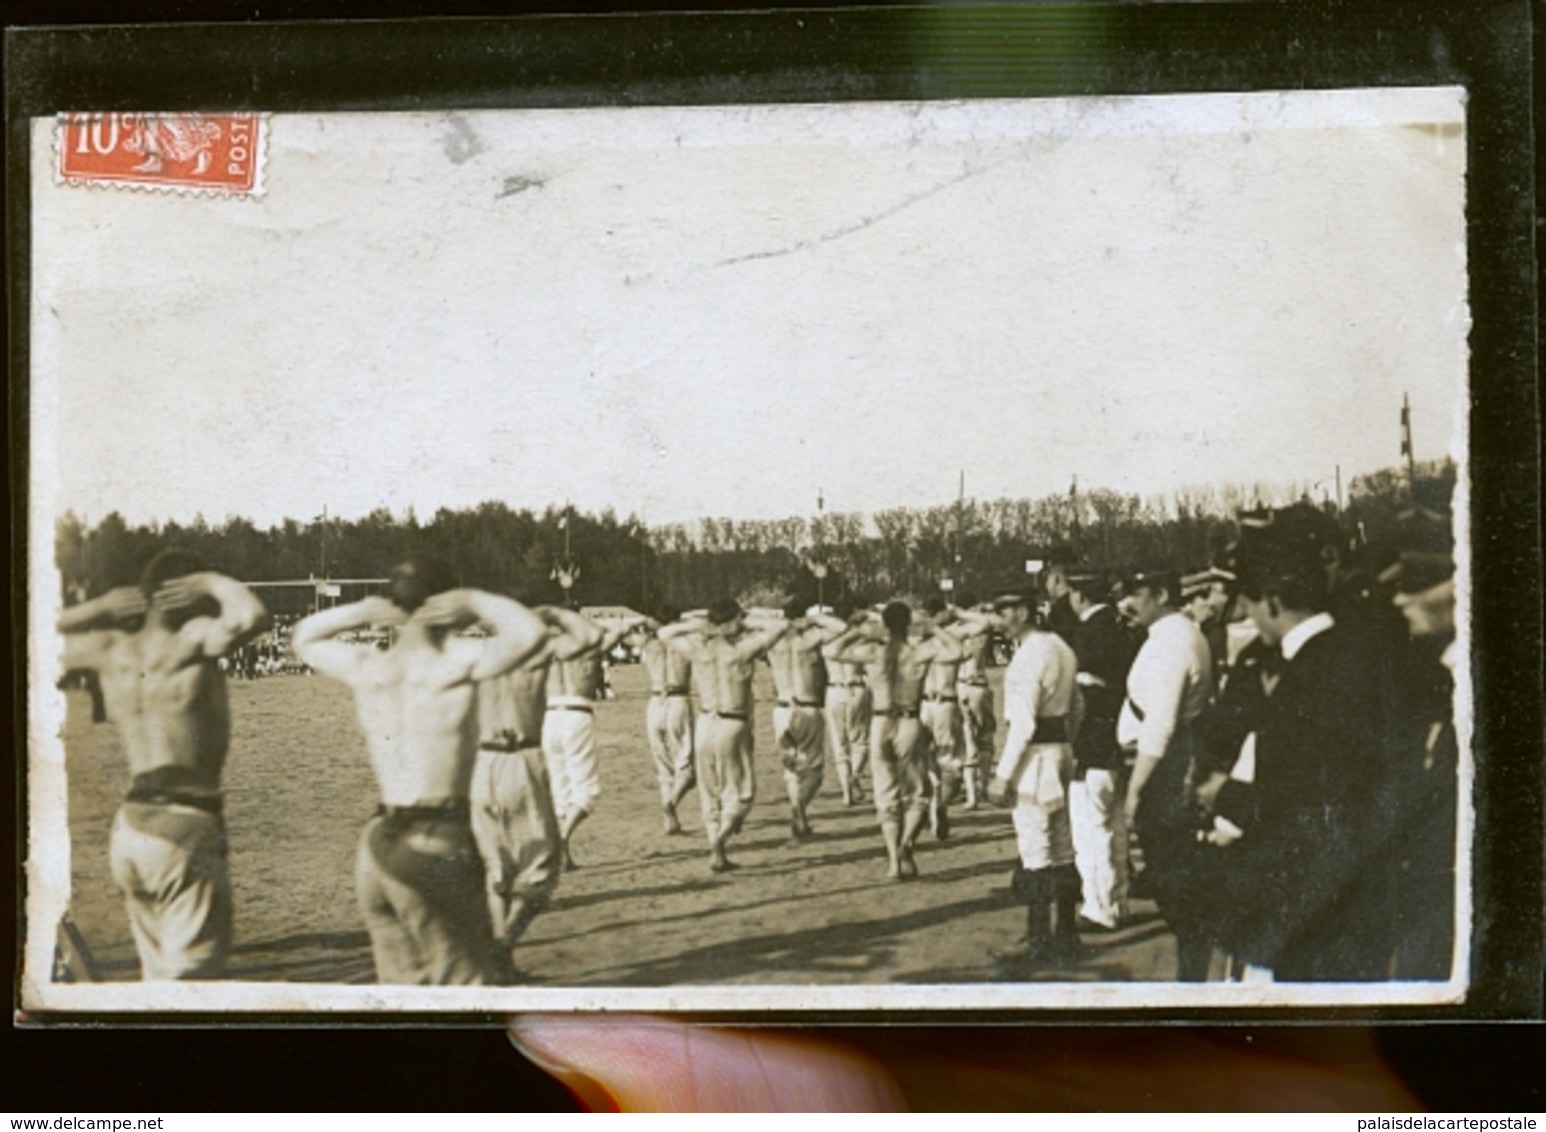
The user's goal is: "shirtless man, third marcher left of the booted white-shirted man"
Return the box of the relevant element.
[822,602,963,880]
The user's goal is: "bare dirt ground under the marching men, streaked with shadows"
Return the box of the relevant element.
[54,665,1175,987]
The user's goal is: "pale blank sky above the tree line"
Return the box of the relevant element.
[32,90,1469,524]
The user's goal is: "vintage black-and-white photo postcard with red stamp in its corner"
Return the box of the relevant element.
[20,85,1487,1018]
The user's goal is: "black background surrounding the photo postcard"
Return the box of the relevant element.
[0,0,1546,1113]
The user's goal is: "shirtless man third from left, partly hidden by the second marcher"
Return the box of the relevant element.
[470,606,601,974]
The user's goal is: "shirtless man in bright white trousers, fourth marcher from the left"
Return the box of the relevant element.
[543,614,643,869]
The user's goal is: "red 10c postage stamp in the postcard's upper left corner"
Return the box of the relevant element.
[57,111,266,196]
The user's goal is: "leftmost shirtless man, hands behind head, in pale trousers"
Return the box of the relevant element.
[59,549,269,979]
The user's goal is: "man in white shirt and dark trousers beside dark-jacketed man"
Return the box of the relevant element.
[1116,571,1214,982]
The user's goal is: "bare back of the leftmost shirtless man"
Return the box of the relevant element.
[96,625,230,789]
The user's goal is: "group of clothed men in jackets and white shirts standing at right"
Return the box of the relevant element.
[989,504,1459,982]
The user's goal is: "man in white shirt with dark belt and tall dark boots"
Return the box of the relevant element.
[988,592,1081,965]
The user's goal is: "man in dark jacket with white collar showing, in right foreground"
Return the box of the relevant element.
[1200,512,1391,982]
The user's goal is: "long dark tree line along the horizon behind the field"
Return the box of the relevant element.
[56,461,1455,612]
